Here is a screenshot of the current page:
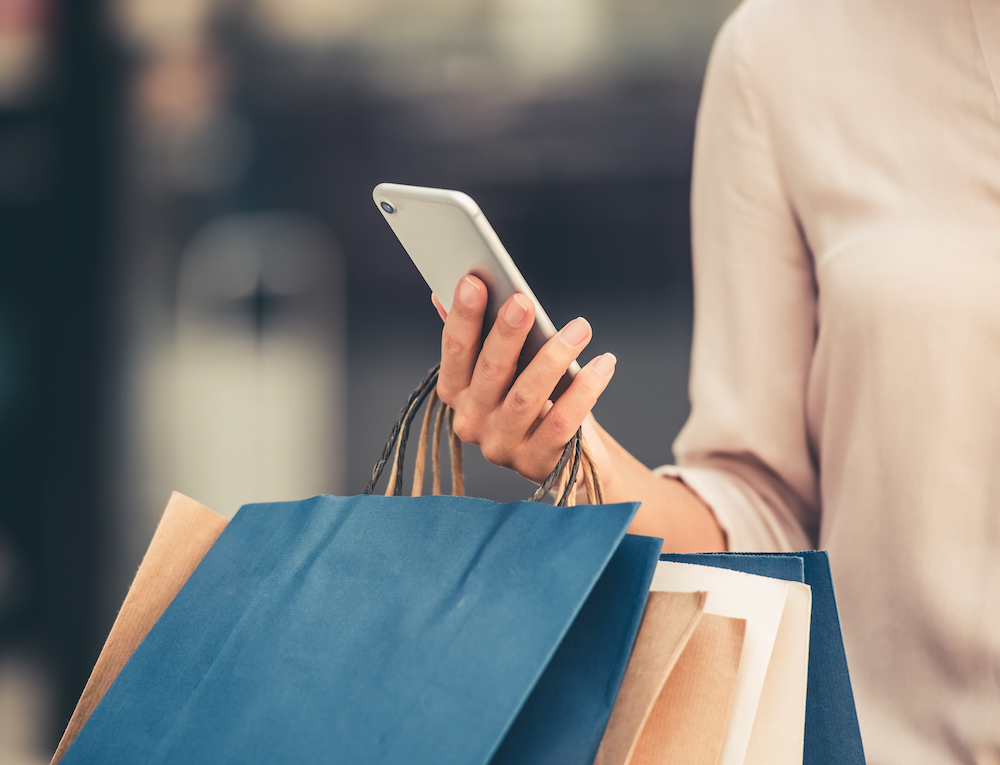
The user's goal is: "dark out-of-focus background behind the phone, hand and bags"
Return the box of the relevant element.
[0,0,735,765]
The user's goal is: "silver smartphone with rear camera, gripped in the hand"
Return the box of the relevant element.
[372,183,580,400]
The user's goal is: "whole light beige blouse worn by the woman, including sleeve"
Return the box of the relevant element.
[661,0,1000,765]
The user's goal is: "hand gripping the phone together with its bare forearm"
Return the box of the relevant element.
[433,276,726,552]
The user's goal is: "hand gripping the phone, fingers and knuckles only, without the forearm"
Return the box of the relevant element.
[435,276,616,483]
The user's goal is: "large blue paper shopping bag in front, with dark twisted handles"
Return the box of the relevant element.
[63,364,660,763]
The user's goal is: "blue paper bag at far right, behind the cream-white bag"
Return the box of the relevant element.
[661,550,865,765]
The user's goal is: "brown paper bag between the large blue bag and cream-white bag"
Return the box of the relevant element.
[594,590,746,765]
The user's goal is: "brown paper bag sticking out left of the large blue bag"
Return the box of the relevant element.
[51,492,228,765]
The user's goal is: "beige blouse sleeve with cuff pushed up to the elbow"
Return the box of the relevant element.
[657,3,819,550]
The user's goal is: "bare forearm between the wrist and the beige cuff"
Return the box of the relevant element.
[587,418,726,552]
